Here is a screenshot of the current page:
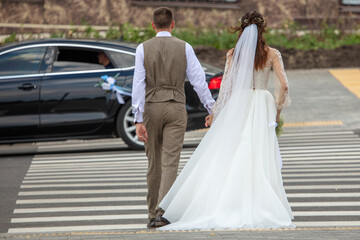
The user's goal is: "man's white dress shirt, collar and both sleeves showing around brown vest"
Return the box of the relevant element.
[132,31,215,122]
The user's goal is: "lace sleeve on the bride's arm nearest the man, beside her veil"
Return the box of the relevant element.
[212,49,234,120]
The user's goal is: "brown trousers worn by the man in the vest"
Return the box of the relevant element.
[144,101,187,218]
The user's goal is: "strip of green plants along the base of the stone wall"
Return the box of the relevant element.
[3,21,360,50]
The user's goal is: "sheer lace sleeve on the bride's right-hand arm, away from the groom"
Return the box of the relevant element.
[273,49,291,110]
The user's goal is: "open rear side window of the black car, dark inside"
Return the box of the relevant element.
[52,47,105,72]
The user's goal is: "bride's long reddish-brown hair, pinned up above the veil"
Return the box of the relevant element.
[229,11,268,70]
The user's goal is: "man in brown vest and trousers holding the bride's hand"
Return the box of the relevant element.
[132,7,215,228]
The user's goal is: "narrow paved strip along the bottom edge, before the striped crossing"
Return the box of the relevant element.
[0,227,360,240]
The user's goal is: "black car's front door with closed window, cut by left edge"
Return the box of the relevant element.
[0,46,47,140]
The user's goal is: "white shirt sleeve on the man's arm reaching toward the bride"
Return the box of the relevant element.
[186,43,215,114]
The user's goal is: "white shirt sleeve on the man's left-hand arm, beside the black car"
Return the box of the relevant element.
[131,44,146,123]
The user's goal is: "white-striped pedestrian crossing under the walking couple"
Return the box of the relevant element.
[8,130,360,233]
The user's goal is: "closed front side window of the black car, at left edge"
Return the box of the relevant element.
[0,47,46,76]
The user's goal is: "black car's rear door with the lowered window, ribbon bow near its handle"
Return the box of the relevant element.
[40,45,126,137]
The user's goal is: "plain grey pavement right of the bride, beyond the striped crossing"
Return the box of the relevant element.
[270,69,360,129]
